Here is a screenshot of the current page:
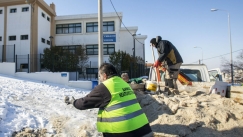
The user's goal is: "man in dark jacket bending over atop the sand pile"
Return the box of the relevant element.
[150,36,183,94]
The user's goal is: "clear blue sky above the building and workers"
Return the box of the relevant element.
[44,0,243,69]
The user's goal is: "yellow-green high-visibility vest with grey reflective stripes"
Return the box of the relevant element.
[97,76,149,133]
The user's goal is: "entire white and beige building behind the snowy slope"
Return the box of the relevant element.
[0,0,147,72]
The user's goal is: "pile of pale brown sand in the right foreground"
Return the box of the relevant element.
[137,87,243,137]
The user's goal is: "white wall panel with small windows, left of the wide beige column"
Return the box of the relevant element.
[6,4,31,58]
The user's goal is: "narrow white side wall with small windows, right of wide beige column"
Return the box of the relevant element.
[38,7,51,54]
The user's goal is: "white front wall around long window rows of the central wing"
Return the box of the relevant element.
[54,14,120,68]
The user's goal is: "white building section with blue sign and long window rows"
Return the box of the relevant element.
[54,13,147,68]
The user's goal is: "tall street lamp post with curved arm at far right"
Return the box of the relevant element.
[211,9,234,85]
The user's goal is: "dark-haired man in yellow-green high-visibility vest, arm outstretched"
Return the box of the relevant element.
[65,63,153,137]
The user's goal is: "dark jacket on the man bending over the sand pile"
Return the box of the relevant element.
[156,40,183,66]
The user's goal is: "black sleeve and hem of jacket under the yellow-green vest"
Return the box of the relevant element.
[73,83,152,137]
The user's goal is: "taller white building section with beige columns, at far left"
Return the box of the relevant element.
[0,0,56,72]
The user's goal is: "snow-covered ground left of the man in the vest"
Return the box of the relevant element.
[0,74,99,137]
